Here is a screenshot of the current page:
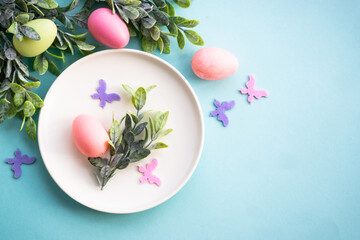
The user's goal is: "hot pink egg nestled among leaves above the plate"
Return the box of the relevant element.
[88,8,130,48]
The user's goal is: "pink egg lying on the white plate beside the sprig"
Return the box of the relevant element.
[72,114,110,157]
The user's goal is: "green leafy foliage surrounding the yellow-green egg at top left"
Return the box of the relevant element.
[0,0,95,140]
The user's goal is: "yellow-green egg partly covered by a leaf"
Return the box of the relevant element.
[13,19,57,57]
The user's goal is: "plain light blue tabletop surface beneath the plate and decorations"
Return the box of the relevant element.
[0,0,360,240]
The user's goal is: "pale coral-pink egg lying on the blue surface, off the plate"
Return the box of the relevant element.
[191,47,239,80]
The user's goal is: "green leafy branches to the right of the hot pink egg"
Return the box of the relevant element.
[83,0,204,53]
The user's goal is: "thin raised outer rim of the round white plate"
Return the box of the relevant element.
[37,49,205,214]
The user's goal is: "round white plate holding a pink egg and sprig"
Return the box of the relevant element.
[38,49,204,213]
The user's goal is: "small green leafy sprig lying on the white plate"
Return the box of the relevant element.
[88,85,173,190]
